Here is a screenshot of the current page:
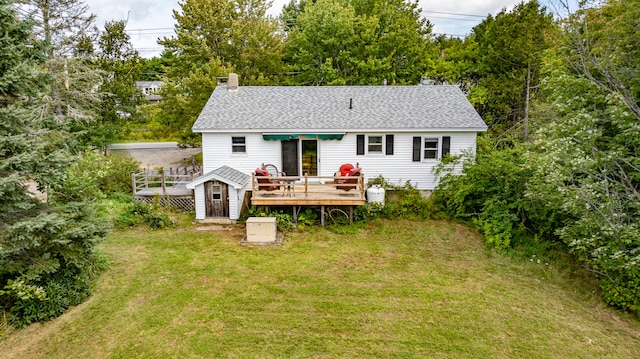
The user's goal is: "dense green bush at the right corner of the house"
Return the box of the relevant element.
[433,139,558,249]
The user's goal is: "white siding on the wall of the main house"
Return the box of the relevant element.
[202,132,476,193]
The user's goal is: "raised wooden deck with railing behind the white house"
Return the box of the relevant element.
[251,175,365,206]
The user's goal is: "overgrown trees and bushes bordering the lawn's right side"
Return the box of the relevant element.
[437,1,640,317]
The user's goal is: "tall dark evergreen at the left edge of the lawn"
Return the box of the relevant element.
[0,0,107,325]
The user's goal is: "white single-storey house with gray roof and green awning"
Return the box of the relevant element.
[187,74,487,220]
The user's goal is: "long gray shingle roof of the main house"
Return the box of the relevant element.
[193,85,487,132]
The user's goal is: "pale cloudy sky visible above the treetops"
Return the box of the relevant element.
[85,0,568,58]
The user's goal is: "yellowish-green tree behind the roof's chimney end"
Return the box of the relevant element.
[159,0,283,144]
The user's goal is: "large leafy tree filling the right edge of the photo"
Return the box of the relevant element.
[529,0,640,316]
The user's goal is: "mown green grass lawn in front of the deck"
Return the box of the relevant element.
[0,221,640,358]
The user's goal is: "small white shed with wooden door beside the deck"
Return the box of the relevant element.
[186,166,251,221]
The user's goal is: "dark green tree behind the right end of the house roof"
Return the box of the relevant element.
[428,0,555,138]
